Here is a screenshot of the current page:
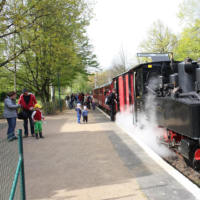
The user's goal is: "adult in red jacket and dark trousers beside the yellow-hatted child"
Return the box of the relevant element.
[18,89,37,137]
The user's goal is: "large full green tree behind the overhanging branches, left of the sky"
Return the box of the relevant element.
[10,0,97,103]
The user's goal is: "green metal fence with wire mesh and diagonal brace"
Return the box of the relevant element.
[0,127,26,200]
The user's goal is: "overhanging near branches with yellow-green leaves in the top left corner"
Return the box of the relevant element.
[0,0,50,67]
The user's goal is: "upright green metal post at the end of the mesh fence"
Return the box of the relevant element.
[18,129,26,200]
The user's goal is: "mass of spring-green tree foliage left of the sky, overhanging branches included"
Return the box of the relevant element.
[0,0,98,102]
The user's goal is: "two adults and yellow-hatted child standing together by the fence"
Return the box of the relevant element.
[3,89,44,141]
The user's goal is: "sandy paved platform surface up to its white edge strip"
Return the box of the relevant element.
[23,110,197,200]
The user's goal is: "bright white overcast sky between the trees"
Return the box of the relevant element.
[88,0,182,69]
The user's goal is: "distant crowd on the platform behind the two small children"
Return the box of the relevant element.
[65,93,95,110]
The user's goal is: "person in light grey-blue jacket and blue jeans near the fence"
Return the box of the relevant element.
[4,92,20,141]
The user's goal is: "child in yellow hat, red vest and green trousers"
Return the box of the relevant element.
[32,104,44,139]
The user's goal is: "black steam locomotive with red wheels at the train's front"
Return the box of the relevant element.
[143,59,200,169]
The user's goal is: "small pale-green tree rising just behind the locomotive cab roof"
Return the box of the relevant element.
[139,20,177,53]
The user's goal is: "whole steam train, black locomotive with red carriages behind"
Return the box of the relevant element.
[93,54,200,170]
